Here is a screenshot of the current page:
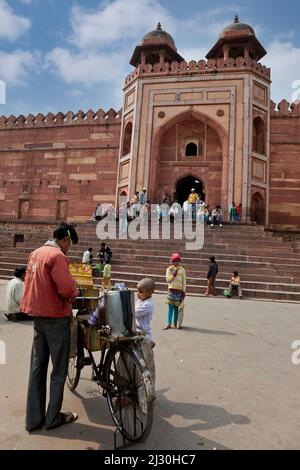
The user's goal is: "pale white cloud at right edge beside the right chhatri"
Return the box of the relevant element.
[262,40,300,102]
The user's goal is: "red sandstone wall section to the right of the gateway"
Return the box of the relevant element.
[270,101,300,226]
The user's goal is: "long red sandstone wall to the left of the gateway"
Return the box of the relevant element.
[0,110,121,221]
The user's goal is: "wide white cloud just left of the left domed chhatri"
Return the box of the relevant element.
[46,47,127,87]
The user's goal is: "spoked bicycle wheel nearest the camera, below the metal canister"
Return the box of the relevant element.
[104,347,153,442]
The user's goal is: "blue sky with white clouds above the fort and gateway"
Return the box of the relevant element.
[0,0,300,115]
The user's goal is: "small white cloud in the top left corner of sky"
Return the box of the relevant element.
[0,0,31,41]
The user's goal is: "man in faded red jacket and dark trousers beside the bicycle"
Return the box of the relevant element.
[21,223,78,432]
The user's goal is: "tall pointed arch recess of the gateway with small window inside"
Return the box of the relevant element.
[148,110,229,207]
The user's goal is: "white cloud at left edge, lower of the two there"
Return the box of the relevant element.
[0,50,39,86]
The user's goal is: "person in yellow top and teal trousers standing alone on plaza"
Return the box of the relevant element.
[164,253,186,330]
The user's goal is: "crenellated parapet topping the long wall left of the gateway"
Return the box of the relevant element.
[0,108,122,129]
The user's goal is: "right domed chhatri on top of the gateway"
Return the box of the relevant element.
[206,15,267,62]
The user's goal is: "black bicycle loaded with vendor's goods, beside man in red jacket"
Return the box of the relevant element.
[67,299,155,446]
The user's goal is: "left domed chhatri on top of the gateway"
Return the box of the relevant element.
[130,23,184,67]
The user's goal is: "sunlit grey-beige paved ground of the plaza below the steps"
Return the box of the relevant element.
[0,281,300,450]
